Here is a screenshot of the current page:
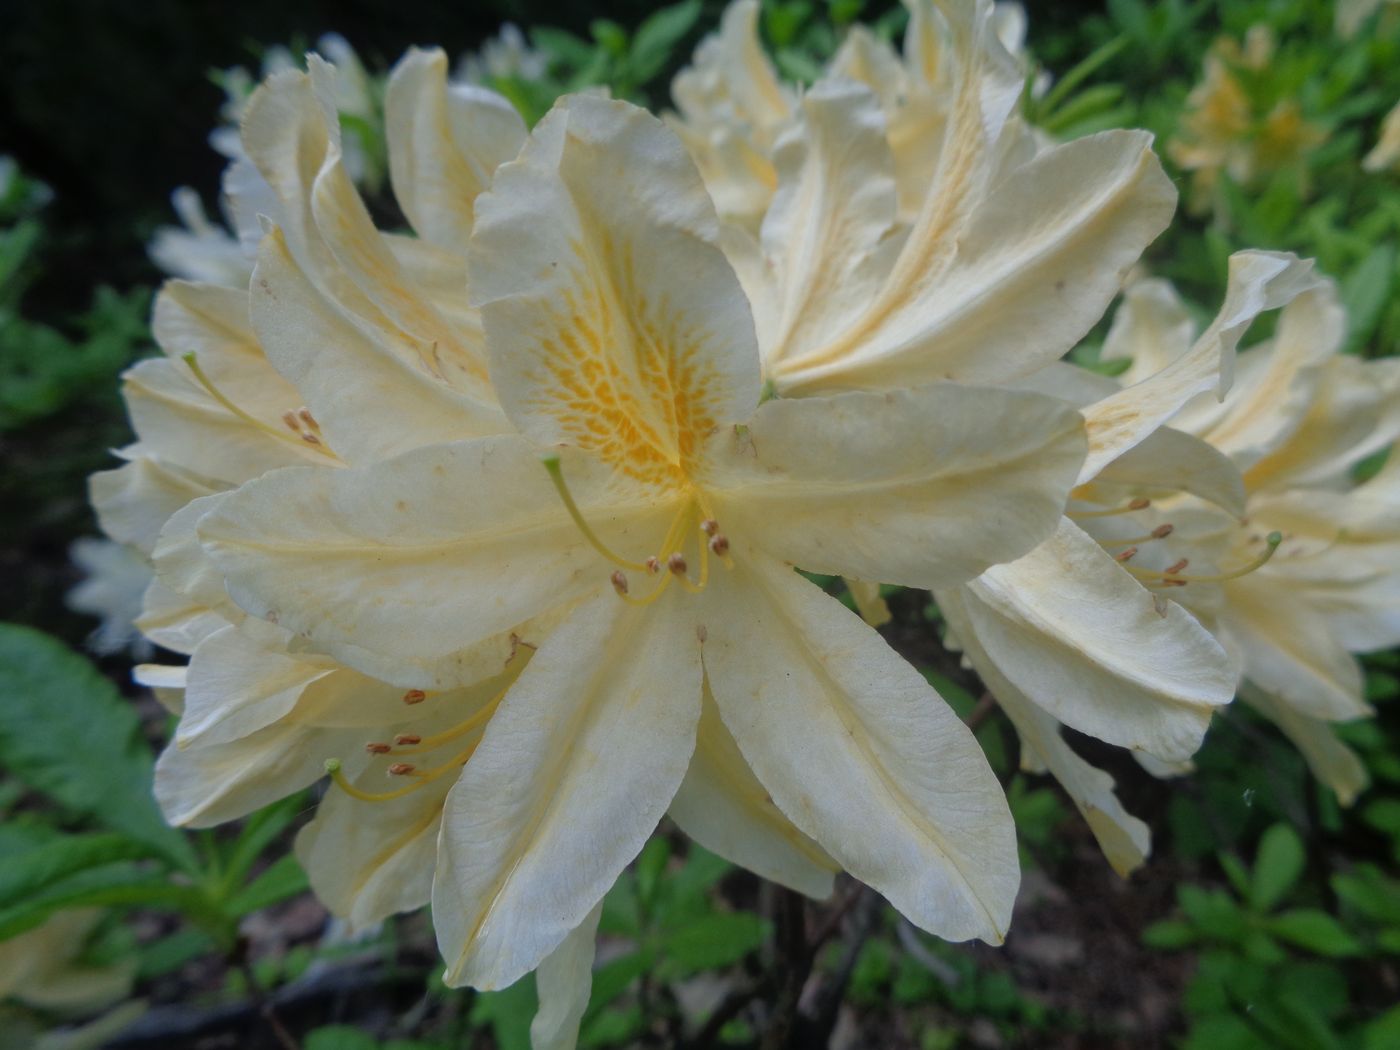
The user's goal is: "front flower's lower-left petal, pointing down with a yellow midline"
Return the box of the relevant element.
[433,591,701,990]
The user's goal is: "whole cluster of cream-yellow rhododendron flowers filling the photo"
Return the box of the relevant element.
[92,0,1400,1047]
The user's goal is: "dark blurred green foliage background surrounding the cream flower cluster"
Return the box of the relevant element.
[0,0,1400,1050]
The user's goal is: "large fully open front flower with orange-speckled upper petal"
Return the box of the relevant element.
[197,90,1082,987]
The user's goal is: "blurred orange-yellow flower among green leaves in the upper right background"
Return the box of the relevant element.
[1168,25,1327,211]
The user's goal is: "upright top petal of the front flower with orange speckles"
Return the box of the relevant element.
[470,97,759,484]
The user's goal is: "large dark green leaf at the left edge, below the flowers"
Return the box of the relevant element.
[0,624,197,872]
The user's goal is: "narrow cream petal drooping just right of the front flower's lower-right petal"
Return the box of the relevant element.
[938,588,1152,878]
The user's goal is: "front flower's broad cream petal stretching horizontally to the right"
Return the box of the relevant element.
[711,384,1084,587]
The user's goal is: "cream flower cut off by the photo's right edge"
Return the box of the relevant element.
[1091,271,1400,801]
